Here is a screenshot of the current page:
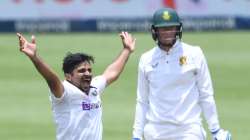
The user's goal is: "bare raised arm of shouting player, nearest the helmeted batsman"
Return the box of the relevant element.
[103,32,136,85]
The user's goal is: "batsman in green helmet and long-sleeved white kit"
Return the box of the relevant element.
[133,8,231,140]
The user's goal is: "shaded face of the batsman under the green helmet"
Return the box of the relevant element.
[157,26,177,47]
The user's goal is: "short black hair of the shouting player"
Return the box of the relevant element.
[62,52,94,74]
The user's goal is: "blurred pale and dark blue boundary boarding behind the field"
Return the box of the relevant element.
[0,0,250,32]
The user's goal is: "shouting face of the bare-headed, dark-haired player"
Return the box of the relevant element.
[67,62,92,94]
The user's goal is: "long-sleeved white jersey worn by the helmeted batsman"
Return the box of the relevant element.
[133,41,219,138]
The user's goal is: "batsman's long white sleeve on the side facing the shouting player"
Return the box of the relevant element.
[133,55,149,139]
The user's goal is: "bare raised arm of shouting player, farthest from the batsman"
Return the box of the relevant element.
[17,33,64,98]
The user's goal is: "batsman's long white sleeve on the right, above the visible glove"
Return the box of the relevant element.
[197,48,220,132]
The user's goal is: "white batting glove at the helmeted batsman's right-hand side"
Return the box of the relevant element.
[212,129,232,140]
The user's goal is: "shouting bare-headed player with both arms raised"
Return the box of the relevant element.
[17,32,135,140]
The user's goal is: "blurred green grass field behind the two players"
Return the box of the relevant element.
[0,32,250,140]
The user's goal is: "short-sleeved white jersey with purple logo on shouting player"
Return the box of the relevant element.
[50,76,106,140]
